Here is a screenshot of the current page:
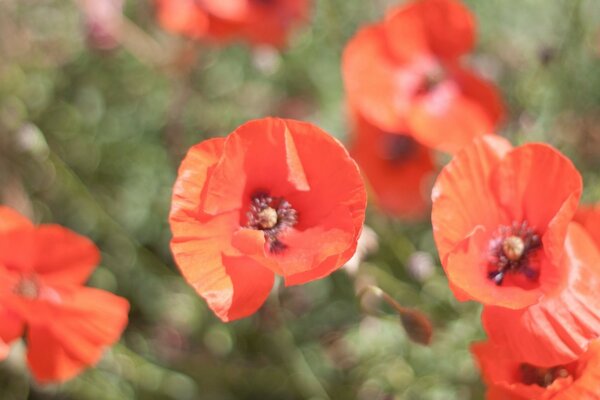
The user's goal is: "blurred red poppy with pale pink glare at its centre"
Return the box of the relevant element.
[342,0,503,153]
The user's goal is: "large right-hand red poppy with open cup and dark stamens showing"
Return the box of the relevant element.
[432,135,582,309]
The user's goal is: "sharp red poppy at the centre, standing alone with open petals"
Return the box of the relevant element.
[170,118,366,321]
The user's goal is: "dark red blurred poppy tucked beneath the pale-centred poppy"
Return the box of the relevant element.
[350,107,436,220]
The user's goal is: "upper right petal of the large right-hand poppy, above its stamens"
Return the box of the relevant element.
[491,143,582,260]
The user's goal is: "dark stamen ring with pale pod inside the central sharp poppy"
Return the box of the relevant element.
[246,192,298,253]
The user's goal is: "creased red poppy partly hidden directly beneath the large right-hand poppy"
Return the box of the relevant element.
[482,222,600,367]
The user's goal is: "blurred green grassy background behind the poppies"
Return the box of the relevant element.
[0,0,600,400]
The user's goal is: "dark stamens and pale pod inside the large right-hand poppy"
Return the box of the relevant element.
[488,221,542,286]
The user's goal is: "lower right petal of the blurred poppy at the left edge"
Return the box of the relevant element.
[27,287,129,383]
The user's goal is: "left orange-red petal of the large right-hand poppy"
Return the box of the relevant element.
[431,136,511,264]
